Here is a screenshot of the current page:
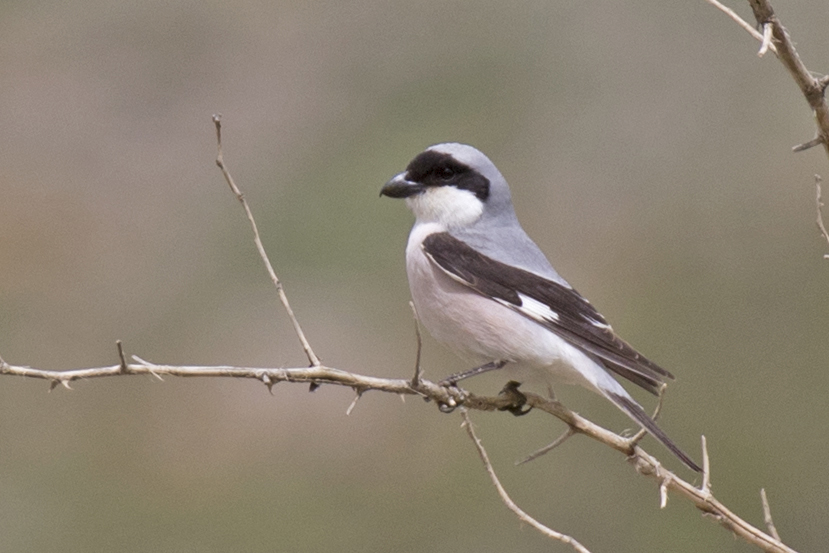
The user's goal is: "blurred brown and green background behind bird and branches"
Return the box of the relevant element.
[0,0,829,553]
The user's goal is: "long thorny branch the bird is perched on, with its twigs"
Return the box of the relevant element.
[0,115,796,553]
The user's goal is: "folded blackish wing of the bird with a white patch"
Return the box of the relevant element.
[422,232,674,394]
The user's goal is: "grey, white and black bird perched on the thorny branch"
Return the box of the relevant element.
[380,143,702,472]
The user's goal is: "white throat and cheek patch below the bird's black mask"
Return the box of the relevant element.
[406,186,484,229]
